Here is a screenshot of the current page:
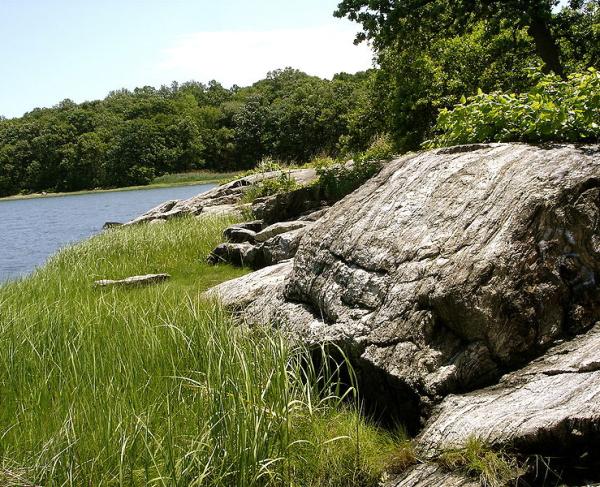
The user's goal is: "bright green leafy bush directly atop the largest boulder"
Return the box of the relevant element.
[424,68,600,148]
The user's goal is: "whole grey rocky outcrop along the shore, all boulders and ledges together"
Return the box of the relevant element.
[130,144,600,486]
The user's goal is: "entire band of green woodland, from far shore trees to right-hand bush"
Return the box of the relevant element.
[0,0,600,196]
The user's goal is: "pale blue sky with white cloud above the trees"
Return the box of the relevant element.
[0,0,372,117]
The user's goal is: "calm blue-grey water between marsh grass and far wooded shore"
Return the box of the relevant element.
[0,184,215,282]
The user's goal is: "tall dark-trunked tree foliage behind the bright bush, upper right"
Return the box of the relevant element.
[336,0,600,152]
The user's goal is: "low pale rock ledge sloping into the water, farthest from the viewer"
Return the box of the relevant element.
[125,169,317,225]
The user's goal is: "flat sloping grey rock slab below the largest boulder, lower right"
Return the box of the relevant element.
[418,325,600,457]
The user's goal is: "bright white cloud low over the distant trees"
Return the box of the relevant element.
[158,24,373,86]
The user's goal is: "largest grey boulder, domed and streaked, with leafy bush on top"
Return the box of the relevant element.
[206,144,600,424]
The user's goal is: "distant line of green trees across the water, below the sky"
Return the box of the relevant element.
[0,68,373,196]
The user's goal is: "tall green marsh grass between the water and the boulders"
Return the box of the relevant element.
[0,218,404,486]
